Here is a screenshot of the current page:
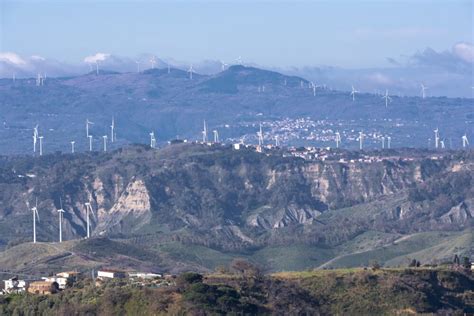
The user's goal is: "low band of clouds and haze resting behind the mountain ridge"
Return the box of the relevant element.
[0,42,474,98]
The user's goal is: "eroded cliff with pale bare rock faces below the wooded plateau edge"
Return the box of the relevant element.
[0,148,468,244]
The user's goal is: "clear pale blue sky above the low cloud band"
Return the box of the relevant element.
[0,0,474,68]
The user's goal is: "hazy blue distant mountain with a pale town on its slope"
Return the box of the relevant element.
[0,65,474,153]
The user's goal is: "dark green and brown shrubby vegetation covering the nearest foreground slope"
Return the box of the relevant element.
[0,263,474,315]
